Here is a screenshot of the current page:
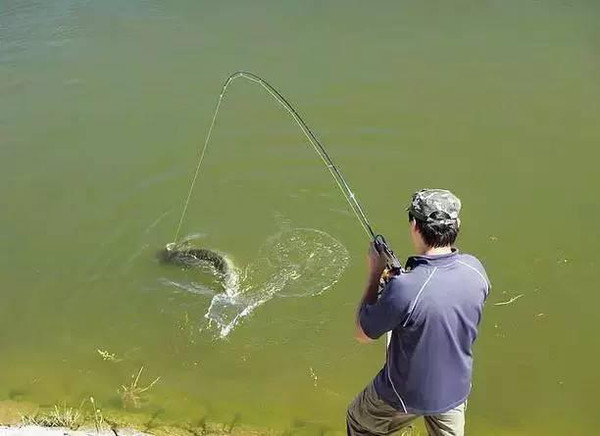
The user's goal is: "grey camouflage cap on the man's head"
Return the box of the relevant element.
[406,189,461,224]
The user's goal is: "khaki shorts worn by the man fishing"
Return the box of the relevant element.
[346,383,466,436]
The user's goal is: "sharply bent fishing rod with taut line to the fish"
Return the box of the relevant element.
[174,71,402,275]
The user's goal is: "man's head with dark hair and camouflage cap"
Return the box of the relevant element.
[406,189,461,252]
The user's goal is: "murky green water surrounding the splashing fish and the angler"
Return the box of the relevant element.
[0,0,600,435]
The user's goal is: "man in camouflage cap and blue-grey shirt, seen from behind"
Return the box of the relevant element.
[346,189,490,436]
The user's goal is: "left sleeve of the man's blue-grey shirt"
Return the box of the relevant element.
[359,279,409,339]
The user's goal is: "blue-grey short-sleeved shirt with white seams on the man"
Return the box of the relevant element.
[360,249,490,415]
